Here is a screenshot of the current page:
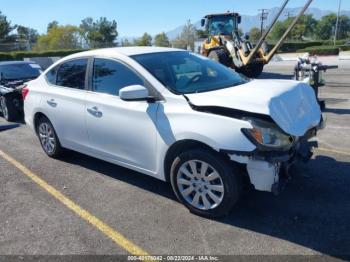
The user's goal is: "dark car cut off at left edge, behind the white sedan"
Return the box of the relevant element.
[0,61,42,121]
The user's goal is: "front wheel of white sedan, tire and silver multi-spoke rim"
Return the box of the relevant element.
[170,149,242,218]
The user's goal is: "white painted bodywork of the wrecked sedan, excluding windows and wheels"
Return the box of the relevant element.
[24,47,321,192]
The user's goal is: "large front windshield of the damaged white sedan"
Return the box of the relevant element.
[132,51,248,94]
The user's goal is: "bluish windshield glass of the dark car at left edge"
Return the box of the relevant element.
[0,64,42,80]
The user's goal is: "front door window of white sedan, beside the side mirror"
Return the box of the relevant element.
[92,58,144,96]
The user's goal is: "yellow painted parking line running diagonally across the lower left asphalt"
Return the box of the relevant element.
[0,150,149,256]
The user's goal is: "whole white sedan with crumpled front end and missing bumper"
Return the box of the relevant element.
[23,47,322,217]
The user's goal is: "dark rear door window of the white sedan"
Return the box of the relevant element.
[56,59,88,89]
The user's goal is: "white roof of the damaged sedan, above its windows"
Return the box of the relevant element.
[65,46,186,58]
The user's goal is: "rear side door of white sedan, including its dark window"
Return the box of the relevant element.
[42,58,89,151]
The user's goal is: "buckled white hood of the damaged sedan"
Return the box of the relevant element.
[186,80,321,136]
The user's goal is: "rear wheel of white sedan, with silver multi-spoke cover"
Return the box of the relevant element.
[36,116,63,158]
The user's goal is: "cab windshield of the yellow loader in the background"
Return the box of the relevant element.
[209,16,236,35]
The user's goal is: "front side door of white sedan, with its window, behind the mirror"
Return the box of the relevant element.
[85,58,158,171]
